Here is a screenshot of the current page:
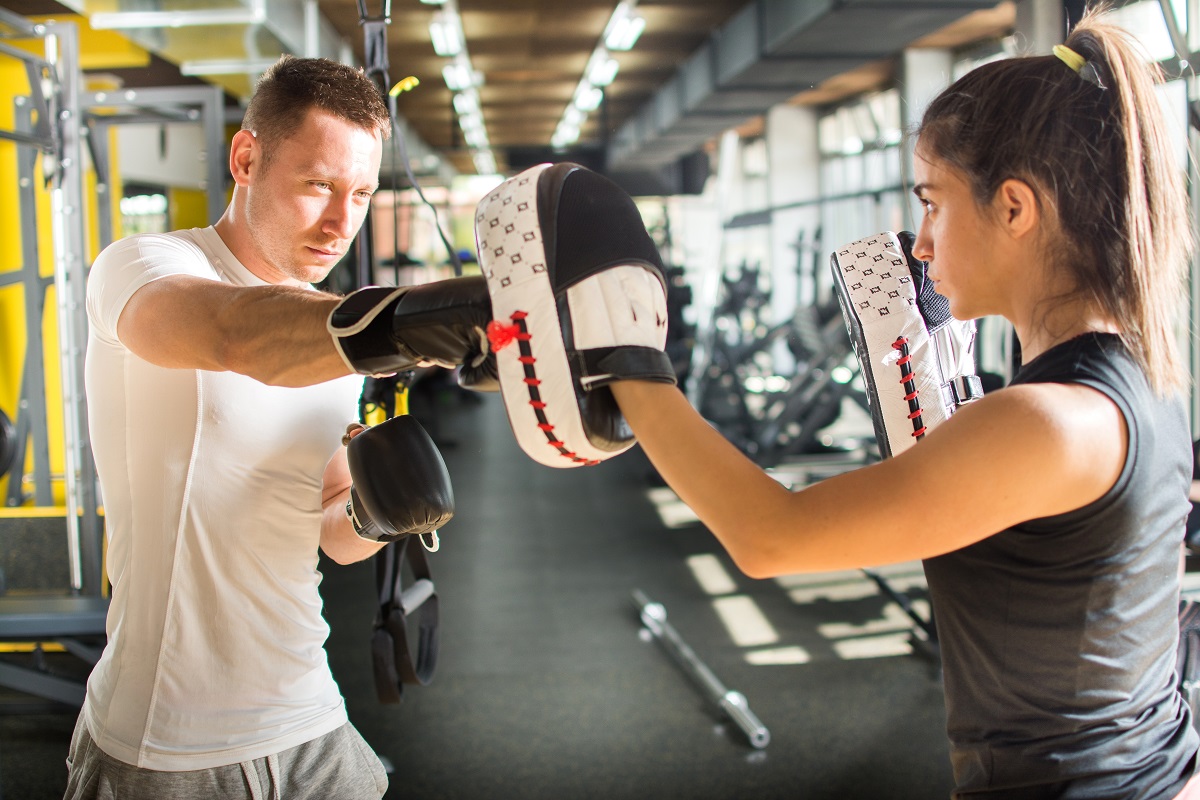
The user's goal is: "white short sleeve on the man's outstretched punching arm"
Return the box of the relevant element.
[86,234,218,342]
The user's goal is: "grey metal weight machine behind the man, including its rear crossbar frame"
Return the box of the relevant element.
[0,8,224,709]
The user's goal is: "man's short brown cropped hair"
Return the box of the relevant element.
[241,55,391,161]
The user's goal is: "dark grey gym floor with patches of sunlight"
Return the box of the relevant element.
[0,390,952,800]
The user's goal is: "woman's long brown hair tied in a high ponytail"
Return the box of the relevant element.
[918,8,1193,395]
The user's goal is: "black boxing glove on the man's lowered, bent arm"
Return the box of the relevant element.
[346,416,454,542]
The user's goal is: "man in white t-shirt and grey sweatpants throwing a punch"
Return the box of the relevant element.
[66,56,482,800]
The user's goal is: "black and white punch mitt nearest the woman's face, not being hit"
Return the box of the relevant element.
[832,231,983,458]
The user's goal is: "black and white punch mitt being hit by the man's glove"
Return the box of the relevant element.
[475,163,676,467]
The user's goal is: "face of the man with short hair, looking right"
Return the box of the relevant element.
[246,110,383,283]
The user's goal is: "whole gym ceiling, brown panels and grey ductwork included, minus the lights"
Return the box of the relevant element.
[0,0,1015,193]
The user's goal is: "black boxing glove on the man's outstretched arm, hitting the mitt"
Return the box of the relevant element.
[328,276,499,391]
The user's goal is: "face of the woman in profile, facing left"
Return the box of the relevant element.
[912,148,1007,319]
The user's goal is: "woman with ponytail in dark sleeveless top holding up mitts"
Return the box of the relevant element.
[613,12,1200,799]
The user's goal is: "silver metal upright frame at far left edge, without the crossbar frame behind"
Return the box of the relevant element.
[0,8,108,704]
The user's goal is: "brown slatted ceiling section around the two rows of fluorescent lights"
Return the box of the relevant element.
[319,0,746,172]
